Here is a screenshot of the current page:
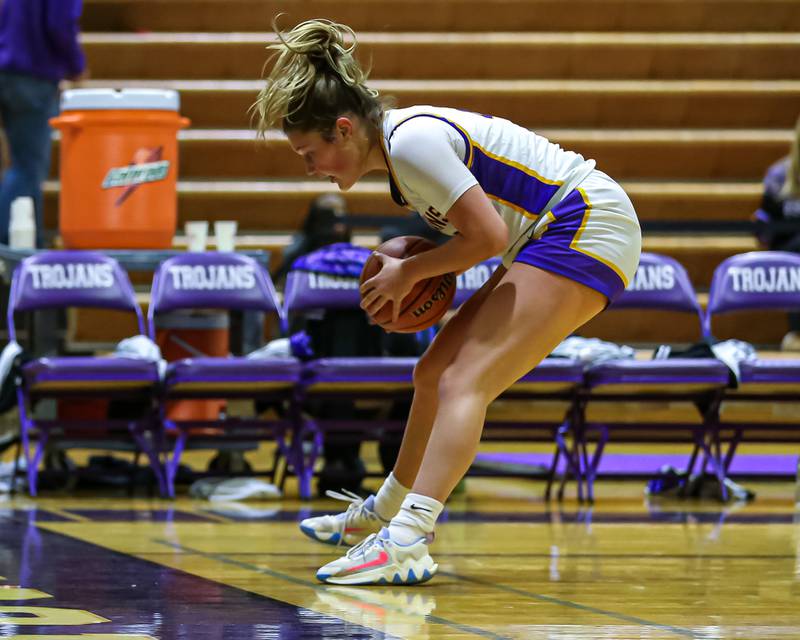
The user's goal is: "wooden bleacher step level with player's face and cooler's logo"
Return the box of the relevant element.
[51,128,794,182]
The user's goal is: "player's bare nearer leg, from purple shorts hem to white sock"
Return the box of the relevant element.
[413,263,607,502]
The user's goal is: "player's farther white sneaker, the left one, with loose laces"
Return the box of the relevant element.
[300,489,389,547]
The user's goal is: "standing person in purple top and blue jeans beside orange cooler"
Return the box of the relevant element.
[0,0,86,246]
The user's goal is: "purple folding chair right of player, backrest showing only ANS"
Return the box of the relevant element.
[572,253,729,501]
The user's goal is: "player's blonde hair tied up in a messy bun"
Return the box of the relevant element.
[251,16,383,137]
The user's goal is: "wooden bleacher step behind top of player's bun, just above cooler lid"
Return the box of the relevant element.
[82,31,800,80]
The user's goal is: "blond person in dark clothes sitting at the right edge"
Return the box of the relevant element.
[754,112,800,351]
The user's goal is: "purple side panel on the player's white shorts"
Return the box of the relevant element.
[514,189,625,302]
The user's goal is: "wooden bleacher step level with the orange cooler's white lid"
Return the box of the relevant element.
[78,79,800,129]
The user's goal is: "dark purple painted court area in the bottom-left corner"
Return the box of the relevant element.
[0,514,385,640]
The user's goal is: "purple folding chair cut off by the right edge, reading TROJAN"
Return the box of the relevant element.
[703,251,800,473]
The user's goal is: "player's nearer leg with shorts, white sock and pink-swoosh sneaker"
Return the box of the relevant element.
[317,171,641,584]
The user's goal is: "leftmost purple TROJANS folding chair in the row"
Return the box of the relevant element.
[8,251,166,496]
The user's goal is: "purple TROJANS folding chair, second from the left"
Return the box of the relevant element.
[147,252,303,497]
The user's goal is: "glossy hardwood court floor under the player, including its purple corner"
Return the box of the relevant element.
[0,478,800,640]
